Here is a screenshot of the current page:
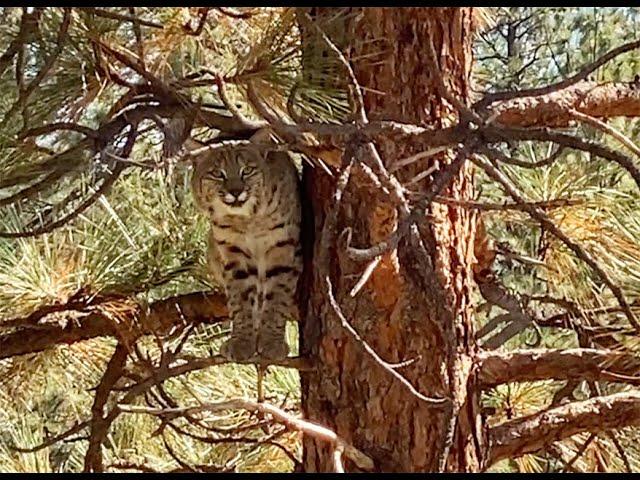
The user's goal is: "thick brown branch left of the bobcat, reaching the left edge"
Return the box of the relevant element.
[0,292,227,360]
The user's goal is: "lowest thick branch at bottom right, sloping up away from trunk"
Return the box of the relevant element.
[487,392,640,465]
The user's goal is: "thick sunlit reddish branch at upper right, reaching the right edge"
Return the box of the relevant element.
[489,82,640,128]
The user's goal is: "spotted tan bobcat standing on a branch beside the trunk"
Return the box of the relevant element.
[192,145,302,361]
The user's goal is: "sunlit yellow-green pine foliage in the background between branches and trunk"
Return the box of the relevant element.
[0,7,640,472]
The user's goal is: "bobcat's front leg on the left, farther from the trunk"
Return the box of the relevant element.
[220,262,257,361]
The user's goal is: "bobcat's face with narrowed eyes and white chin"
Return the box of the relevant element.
[194,148,264,214]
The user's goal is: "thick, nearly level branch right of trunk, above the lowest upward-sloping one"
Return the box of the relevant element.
[478,348,640,388]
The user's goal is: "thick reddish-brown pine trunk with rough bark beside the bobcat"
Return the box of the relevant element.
[302,8,486,472]
